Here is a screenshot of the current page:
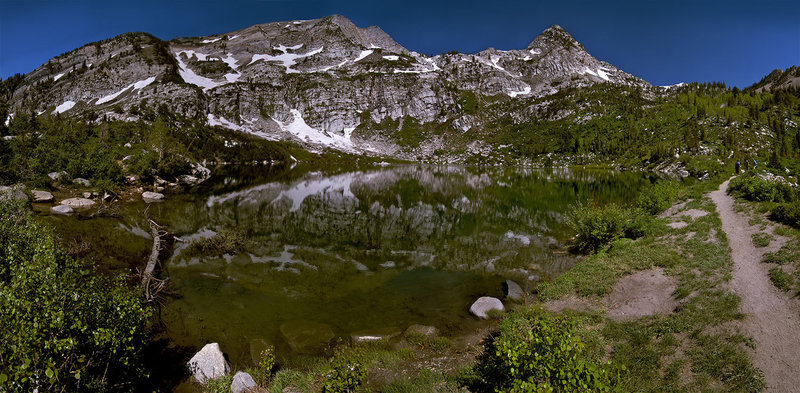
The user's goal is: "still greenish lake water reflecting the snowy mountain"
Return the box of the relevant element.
[40,165,650,365]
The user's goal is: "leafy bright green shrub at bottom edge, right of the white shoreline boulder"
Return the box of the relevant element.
[479,308,619,392]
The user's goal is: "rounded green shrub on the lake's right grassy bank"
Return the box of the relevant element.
[567,203,631,252]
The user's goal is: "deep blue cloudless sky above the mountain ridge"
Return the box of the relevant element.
[0,0,800,87]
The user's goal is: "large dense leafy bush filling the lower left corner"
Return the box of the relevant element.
[0,203,149,392]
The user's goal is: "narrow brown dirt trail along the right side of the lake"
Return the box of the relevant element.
[710,181,800,392]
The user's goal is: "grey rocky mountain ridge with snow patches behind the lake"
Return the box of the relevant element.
[3,15,649,157]
